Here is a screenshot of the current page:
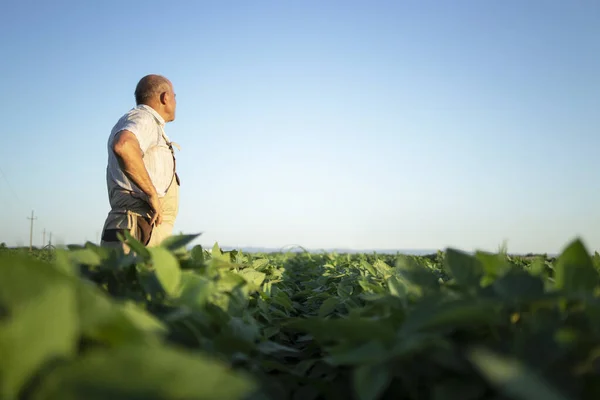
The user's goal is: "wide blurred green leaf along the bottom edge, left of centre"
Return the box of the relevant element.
[33,346,256,400]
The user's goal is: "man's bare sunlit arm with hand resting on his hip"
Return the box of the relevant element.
[112,130,162,225]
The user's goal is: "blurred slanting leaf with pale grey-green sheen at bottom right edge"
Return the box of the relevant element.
[468,348,567,400]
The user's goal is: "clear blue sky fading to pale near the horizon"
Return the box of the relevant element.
[0,0,600,252]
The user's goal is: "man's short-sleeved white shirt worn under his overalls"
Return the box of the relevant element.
[106,104,174,198]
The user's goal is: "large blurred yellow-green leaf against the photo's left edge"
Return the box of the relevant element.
[0,255,78,399]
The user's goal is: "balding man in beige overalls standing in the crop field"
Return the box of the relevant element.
[101,75,179,251]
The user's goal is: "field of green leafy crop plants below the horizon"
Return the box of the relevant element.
[0,236,600,400]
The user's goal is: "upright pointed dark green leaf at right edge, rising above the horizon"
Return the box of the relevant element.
[554,239,598,293]
